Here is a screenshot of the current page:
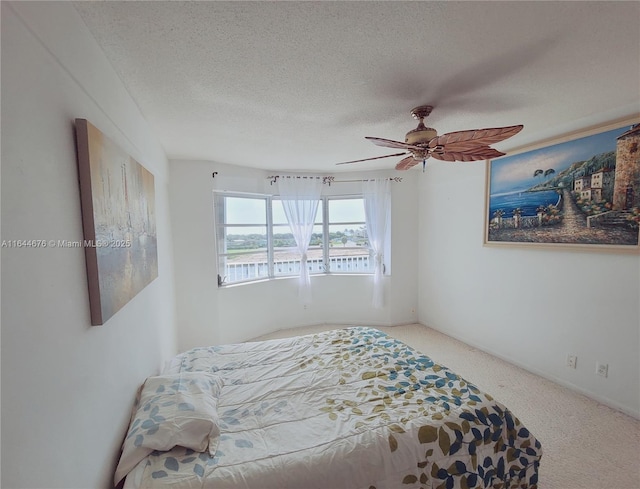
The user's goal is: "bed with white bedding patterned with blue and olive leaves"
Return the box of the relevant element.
[116,327,542,489]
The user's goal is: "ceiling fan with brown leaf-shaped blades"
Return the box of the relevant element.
[337,105,524,170]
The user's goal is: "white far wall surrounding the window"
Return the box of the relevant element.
[170,161,418,349]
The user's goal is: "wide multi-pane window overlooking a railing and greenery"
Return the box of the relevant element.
[214,193,382,285]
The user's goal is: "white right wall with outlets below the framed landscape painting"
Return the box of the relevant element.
[418,162,640,417]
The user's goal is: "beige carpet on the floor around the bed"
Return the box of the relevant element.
[256,324,640,489]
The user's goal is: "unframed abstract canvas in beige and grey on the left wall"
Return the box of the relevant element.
[76,119,158,325]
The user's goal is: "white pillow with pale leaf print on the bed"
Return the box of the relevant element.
[115,372,223,485]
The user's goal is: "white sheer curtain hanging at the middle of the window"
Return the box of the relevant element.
[278,176,322,304]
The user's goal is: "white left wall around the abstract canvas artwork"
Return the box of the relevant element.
[1,2,175,489]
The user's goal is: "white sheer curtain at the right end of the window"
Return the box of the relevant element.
[362,178,391,308]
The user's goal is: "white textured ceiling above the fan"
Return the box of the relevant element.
[74,1,640,172]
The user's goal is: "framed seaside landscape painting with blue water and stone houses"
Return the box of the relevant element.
[484,120,640,253]
